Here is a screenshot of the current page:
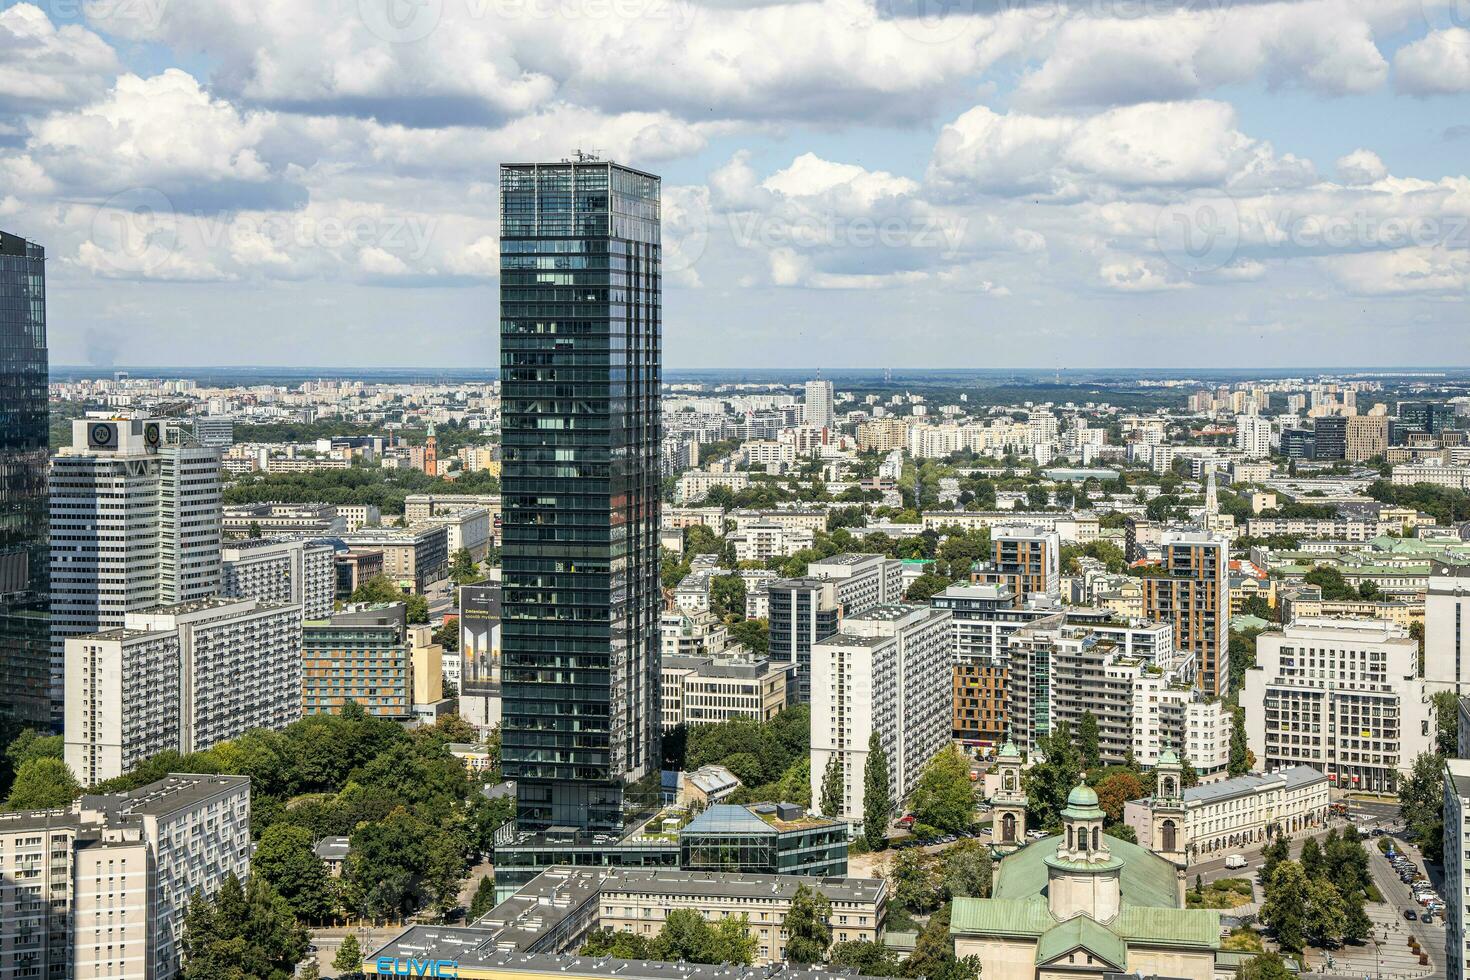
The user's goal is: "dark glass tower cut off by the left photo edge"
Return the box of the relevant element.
[0,232,51,727]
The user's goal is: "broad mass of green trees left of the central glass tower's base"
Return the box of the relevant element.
[7,702,510,934]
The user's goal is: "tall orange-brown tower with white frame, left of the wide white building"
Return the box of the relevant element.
[1142,530,1230,696]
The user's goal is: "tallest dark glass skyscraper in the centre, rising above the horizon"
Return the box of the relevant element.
[500,156,662,832]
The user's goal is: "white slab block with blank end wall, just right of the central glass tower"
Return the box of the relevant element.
[811,604,951,824]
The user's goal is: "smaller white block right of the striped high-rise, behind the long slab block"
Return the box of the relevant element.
[221,538,337,620]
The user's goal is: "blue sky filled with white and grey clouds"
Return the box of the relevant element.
[0,0,1470,369]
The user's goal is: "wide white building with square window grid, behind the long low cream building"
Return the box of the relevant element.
[1241,617,1433,792]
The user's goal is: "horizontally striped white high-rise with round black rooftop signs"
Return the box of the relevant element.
[50,419,221,717]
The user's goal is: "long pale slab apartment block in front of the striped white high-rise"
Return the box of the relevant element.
[66,597,301,786]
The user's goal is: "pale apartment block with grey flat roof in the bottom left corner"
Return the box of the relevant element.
[0,776,250,980]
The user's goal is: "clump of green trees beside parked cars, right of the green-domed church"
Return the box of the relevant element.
[1260,827,1373,952]
